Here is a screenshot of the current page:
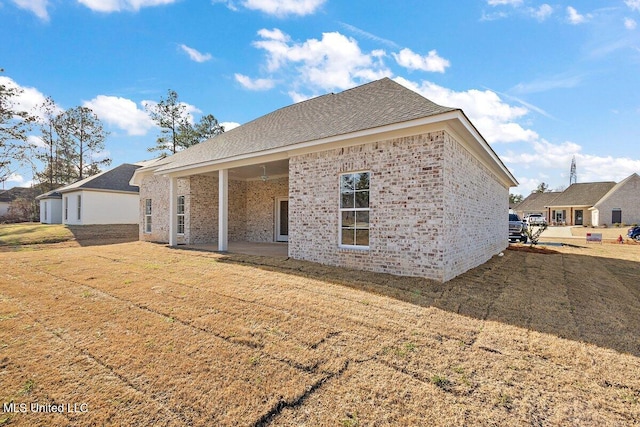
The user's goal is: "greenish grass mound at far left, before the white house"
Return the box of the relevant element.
[0,223,73,246]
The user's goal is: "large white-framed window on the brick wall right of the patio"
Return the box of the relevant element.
[340,172,371,248]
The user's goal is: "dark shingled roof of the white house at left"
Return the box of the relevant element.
[37,163,141,199]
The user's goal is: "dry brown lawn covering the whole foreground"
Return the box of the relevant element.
[0,242,640,426]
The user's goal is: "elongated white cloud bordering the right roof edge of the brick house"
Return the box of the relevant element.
[395,77,538,143]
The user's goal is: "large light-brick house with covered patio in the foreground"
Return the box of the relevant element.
[131,78,517,281]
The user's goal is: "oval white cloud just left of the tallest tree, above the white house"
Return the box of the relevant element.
[84,95,154,135]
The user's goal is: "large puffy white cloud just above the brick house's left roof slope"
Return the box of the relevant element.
[254,29,391,97]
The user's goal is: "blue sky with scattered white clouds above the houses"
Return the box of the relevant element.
[0,0,640,195]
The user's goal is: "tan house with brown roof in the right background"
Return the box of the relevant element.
[513,173,640,227]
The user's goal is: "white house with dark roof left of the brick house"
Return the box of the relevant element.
[37,163,141,225]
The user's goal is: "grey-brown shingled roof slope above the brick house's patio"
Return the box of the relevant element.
[154,78,459,171]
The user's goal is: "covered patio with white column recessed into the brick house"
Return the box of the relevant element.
[167,158,289,251]
